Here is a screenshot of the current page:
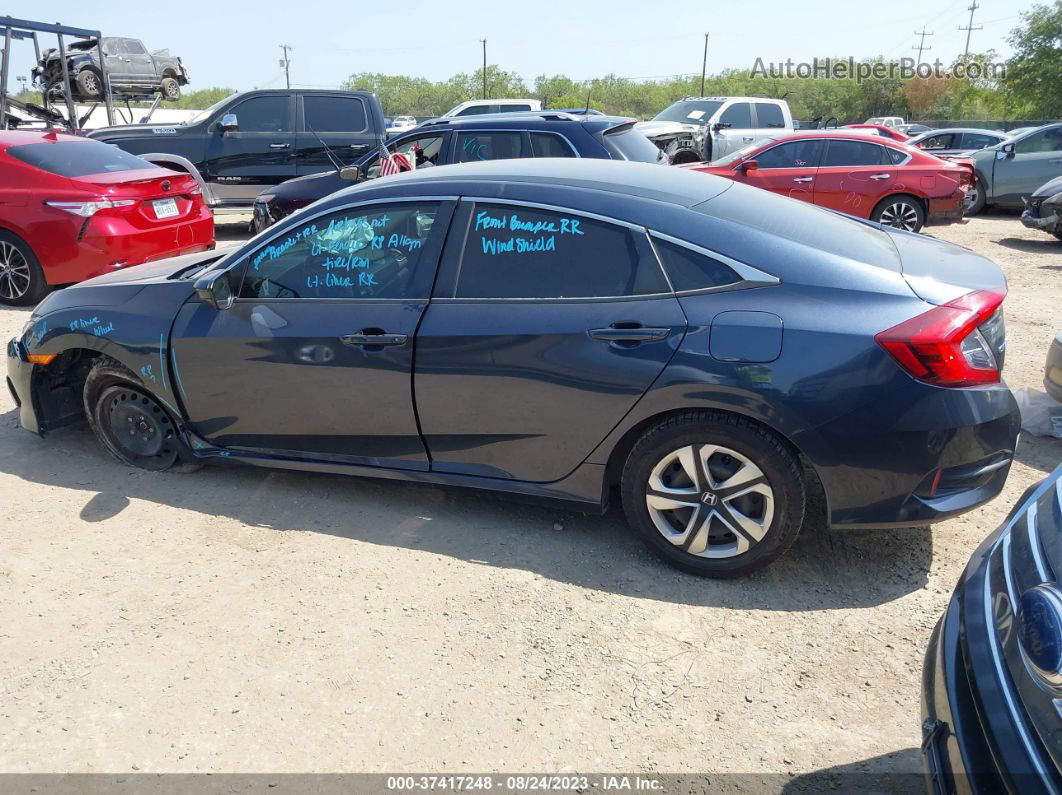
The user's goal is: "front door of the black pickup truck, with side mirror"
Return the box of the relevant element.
[203,93,295,205]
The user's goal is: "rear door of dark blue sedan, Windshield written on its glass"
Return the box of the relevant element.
[413,200,686,482]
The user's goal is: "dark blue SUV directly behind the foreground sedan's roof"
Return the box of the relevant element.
[253,110,667,231]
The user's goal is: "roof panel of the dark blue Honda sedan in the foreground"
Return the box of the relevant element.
[336,157,733,207]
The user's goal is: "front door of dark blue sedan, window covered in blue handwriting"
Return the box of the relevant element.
[172,200,453,469]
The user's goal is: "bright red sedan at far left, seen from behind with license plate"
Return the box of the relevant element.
[0,131,213,304]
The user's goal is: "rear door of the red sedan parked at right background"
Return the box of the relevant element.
[815,138,902,218]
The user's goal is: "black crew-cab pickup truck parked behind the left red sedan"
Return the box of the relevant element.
[88,88,387,212]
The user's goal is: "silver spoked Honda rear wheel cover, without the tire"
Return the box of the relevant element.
[646,445,774,558]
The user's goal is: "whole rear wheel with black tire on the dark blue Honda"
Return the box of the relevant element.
[620,411,806,577]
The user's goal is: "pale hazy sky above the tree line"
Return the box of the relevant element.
[3,0,1033,90]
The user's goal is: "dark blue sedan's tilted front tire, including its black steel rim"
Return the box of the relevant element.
[84,357,200,472]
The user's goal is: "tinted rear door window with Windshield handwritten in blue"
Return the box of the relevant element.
[456,204,670,298]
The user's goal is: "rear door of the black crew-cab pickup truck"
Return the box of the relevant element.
[295,93,379,175]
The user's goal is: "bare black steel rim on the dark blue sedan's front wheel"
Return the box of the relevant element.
[96,384,177,470]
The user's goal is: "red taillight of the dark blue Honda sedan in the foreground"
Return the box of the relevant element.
[874,290,1007,386]
